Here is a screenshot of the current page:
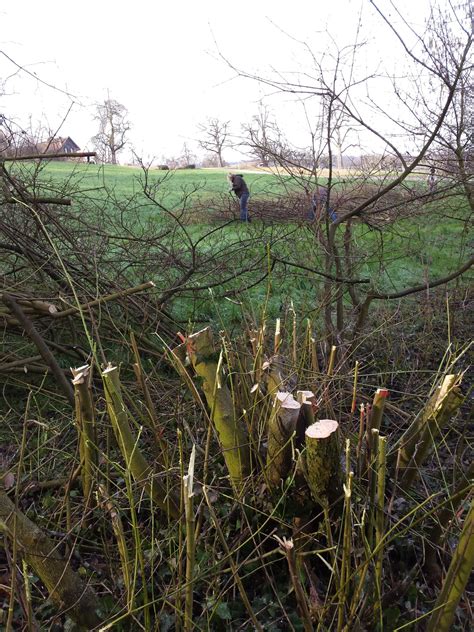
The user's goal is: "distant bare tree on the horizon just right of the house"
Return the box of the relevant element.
[92,99,131,165]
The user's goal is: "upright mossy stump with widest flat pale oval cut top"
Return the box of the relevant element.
[305,419,342,507]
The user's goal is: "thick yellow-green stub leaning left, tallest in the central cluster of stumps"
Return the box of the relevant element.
[186,327,250,486]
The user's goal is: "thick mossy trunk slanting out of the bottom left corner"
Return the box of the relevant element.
[0,491,100,630]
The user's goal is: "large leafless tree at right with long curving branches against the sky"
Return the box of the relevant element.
[221,1,473,348]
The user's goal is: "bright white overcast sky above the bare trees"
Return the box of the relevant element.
[0,0,460,163]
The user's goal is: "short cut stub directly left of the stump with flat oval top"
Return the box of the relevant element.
[266,391,301,487]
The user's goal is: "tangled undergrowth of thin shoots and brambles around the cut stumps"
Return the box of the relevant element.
[0,295,472,632]
